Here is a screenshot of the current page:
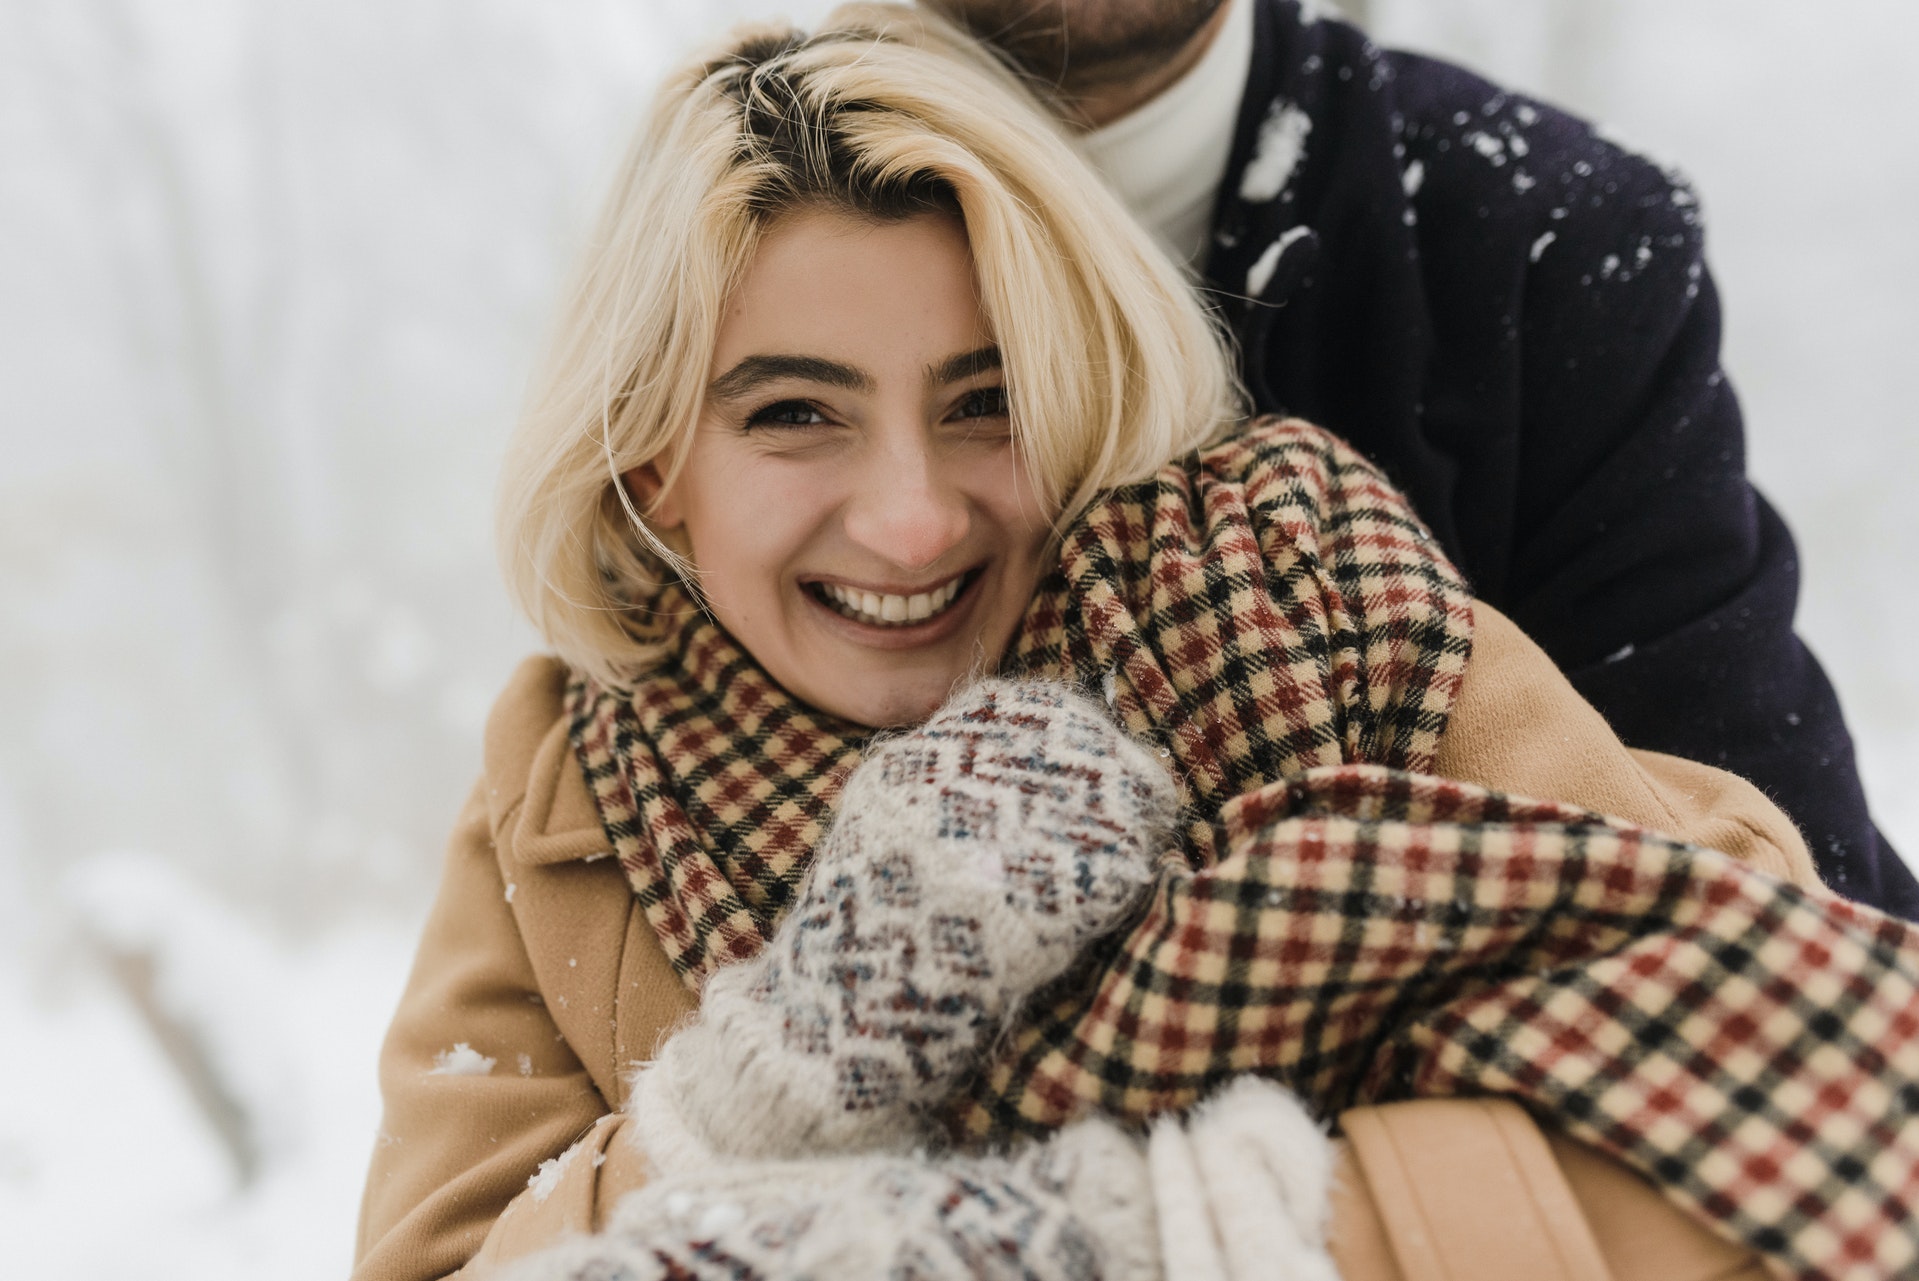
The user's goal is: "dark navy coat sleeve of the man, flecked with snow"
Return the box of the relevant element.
[1503,130,1919,917]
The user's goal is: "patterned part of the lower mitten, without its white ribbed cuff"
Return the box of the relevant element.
[509,1120,1159,1281]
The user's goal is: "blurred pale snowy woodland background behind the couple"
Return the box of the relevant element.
[0,0,1919,1281]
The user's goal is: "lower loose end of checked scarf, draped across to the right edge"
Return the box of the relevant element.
[948,765,1919,1279]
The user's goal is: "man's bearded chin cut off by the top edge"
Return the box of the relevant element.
[927,0,1226,92]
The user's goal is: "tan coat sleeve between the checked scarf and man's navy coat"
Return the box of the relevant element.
[1435,600,1819,886]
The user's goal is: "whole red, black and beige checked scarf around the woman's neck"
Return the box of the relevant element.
[570,422,1919,1277]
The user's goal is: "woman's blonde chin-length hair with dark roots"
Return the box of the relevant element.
[499,4,1242,685]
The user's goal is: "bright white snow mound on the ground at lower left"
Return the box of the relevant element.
[0,853,416,1281]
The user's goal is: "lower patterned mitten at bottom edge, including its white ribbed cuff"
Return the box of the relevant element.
[510,1078,1338,1281]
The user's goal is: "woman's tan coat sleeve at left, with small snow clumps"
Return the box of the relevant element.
[353,788,643,1281]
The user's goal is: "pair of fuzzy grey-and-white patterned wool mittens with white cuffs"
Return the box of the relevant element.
[598,681,1330,1281]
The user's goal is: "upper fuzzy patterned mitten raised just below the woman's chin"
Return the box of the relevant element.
[628,681,1176,1172]
